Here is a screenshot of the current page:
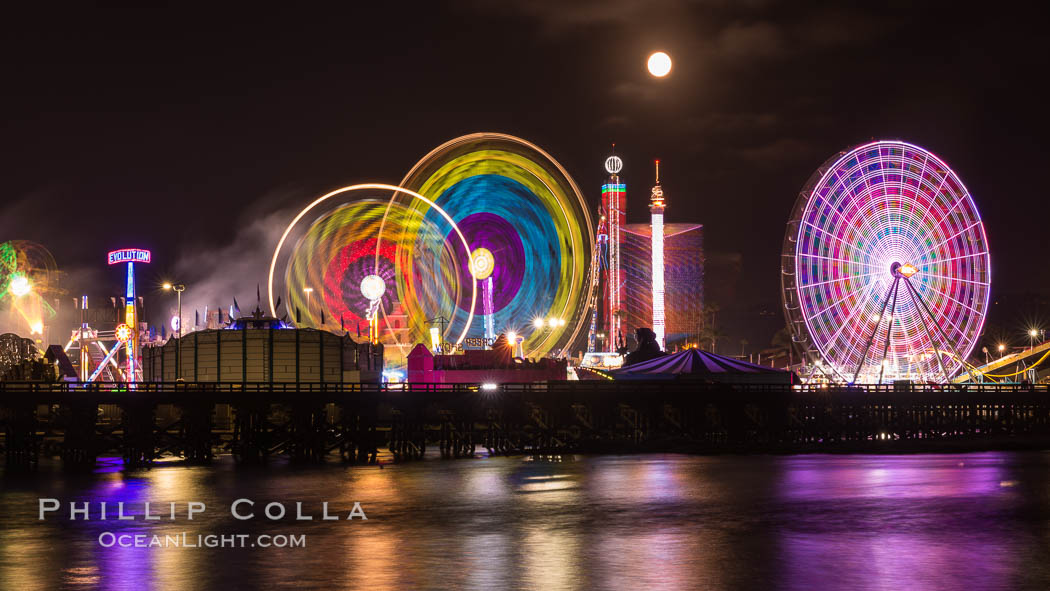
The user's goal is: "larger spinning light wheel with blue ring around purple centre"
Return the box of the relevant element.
[392,133,594,356]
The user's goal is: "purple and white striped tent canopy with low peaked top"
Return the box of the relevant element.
[610,349,797,384]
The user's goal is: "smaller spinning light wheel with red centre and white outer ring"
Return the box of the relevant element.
[267,183,478,359]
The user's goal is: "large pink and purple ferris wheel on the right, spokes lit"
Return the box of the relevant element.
[781,141,991,383]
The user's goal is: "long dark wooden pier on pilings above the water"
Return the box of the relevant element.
[0,381,1050,469]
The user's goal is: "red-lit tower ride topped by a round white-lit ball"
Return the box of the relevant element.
[602,150,627,352]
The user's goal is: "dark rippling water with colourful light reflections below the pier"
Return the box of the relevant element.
[0,452,1050,591]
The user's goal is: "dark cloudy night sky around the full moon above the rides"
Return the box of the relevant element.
[0,0,1050,350]
